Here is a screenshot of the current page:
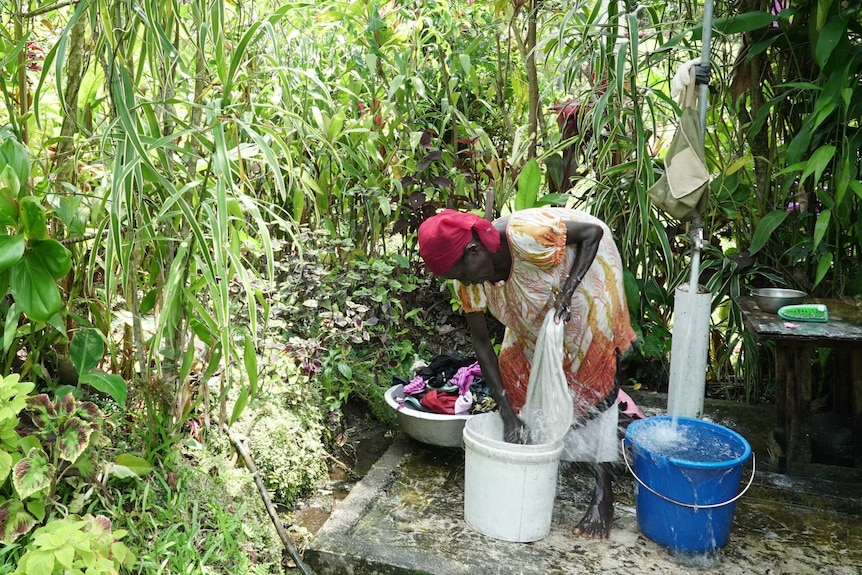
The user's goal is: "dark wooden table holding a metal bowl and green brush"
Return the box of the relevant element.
[735,296,862,473]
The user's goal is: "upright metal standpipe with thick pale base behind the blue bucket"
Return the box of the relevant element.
[667,0,713,417]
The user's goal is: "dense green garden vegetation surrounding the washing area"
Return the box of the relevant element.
[0,0,862,573]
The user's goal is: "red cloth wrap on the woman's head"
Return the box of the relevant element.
[419,210,500,275]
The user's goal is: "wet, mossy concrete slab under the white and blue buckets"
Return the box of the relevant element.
[305,393,862,575]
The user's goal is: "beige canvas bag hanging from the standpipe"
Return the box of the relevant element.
[647,68,709,221]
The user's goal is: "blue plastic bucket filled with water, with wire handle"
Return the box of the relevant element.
[623,416,754,553]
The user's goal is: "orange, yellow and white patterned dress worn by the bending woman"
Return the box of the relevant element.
[455,208,636,418]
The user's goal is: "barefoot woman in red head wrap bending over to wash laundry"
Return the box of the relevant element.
[419,208,636,538]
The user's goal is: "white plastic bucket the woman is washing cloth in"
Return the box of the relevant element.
[464,413,563,543]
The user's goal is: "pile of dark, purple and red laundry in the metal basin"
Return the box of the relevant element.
[392,351,497,415]
